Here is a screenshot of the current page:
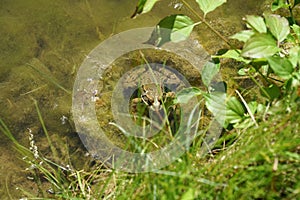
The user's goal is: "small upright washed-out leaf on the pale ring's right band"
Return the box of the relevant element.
[201,62,220,87]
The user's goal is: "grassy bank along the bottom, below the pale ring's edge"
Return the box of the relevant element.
[0,98,300,200]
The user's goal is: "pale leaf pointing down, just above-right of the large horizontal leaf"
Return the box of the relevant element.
[265,15,290,42]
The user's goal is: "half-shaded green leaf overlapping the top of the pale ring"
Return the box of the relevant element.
[147,15,197,46]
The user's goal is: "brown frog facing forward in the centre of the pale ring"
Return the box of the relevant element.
[124,65,181,125]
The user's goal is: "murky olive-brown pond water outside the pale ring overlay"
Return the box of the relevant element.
[0,0,268,199]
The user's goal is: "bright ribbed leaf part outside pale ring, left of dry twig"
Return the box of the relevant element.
[226,97,245,124]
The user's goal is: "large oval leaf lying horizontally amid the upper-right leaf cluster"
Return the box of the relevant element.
[241,33,280,58]
